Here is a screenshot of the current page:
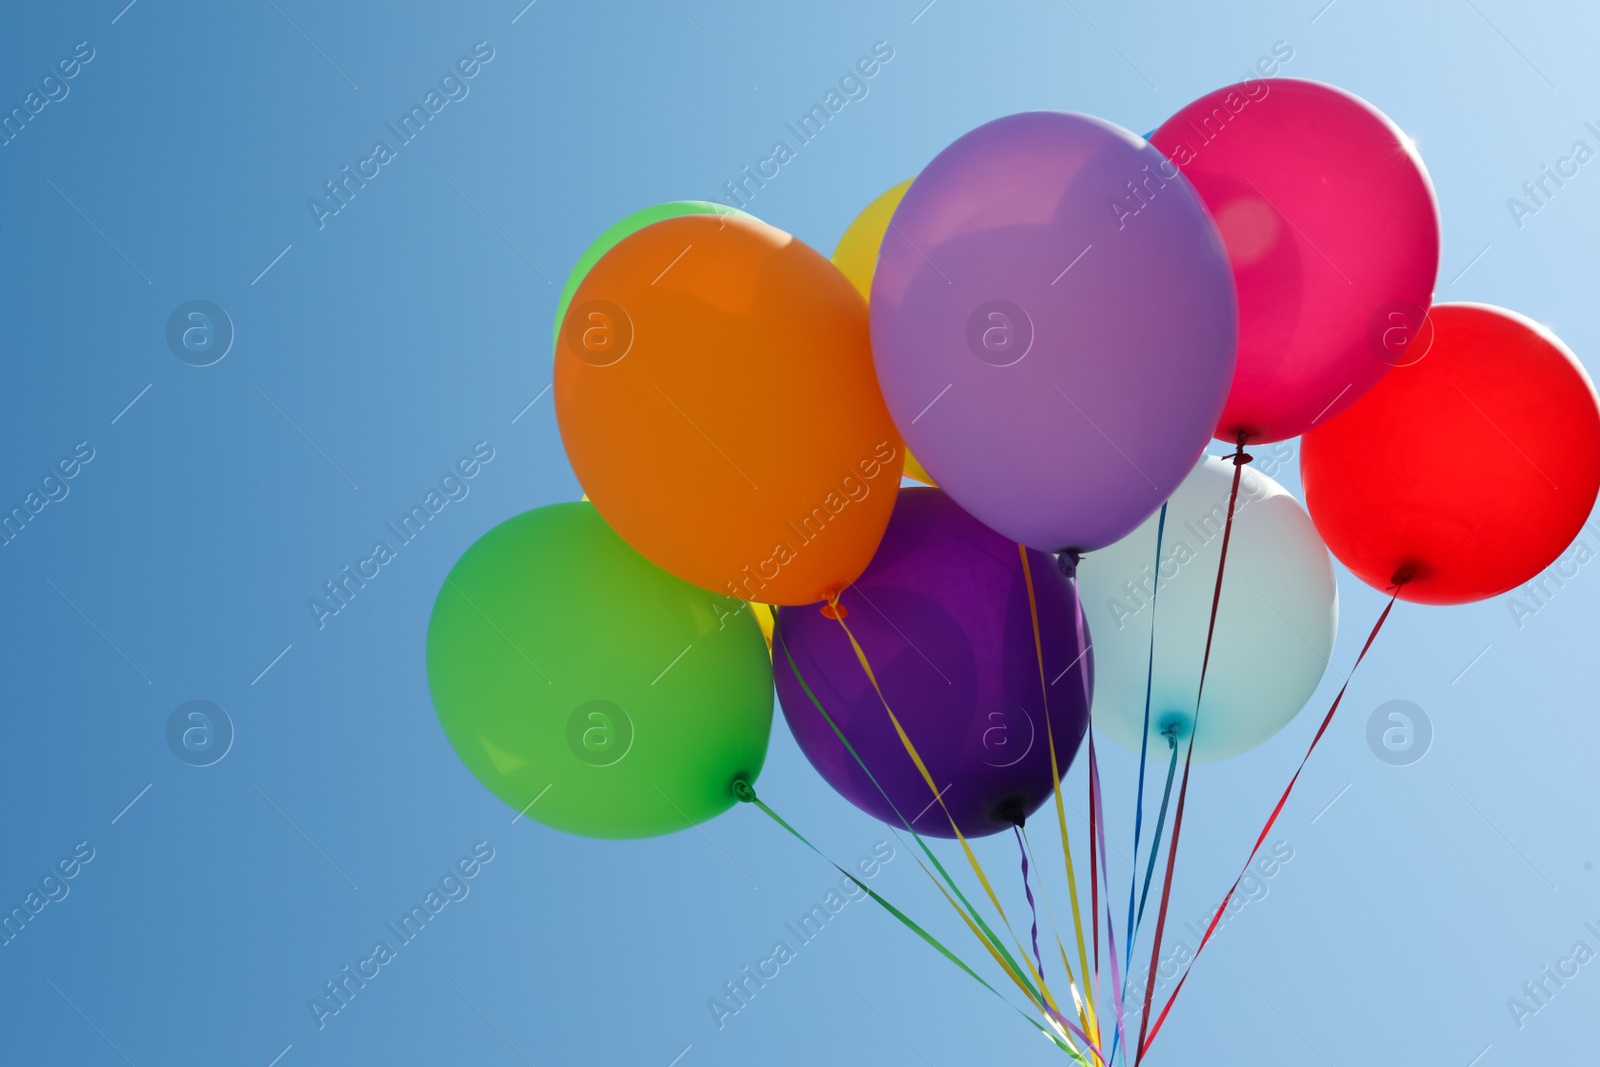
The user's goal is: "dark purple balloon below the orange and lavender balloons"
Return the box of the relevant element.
[773,488,1093,837]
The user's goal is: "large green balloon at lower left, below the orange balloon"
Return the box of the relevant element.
[427,502,773,838]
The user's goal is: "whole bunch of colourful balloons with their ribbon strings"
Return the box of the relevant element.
[427,78,1600,1064]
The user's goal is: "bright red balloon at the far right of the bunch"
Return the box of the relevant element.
[1301,304,1600,603]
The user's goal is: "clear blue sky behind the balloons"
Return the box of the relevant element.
[0,0,1600,1067]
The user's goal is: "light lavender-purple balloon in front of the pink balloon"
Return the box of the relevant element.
[872,112,1238,552]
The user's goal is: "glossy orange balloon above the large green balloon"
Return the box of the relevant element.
[555,214,904,605]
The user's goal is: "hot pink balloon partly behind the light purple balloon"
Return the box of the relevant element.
[1150,78,1438,443]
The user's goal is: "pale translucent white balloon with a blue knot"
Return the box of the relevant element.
[1078,456,1339,761]
